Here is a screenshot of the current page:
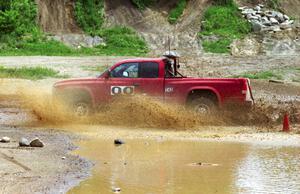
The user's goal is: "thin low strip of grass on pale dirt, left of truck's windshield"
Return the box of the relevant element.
[0,66,68,80]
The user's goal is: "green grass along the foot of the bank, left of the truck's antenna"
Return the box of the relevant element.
[0,27,148,56]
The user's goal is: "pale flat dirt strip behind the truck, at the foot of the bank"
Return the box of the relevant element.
[0,54,300,78]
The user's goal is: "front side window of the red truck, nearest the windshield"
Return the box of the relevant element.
[110,63,139,78]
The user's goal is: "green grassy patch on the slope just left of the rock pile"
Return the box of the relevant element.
[199,5,251,53]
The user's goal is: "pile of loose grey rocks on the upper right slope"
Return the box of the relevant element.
[239,4,294,32]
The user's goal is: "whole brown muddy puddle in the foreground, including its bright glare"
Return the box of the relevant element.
[69,139,300,194]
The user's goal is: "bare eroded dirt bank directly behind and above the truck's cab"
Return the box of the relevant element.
[105,0,210,55]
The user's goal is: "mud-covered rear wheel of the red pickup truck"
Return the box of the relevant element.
[189,97,217,115]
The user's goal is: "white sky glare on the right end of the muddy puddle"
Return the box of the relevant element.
[236,147,300,194]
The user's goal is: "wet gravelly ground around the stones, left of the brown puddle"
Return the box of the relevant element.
[0,125,92,194]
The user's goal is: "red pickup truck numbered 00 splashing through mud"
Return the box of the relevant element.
[53,55,254,116]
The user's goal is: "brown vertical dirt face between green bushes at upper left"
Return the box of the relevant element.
[36,0,81,34]
